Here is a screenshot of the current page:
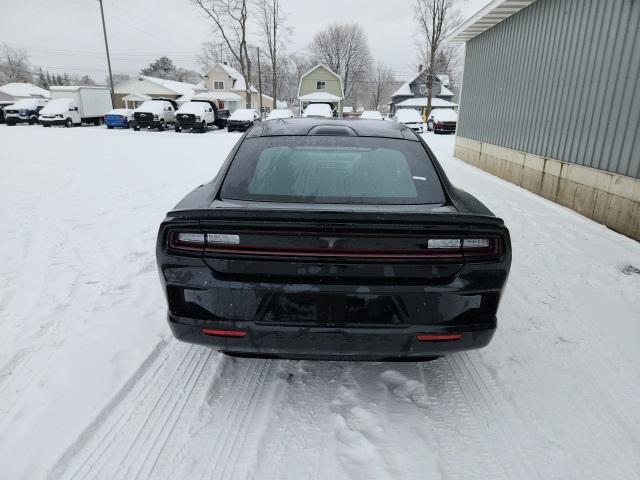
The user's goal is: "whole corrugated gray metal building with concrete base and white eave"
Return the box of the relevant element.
[448,0,640,240]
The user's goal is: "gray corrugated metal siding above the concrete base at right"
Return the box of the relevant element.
[458,0,640,178]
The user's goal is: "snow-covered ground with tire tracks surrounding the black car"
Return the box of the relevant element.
[0,126,640,480]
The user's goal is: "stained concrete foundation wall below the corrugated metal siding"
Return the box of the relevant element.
[454,137,640,240]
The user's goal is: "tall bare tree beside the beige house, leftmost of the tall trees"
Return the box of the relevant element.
[191,0,251,108]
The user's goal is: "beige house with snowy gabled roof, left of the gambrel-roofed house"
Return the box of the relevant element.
[198,62,273,113]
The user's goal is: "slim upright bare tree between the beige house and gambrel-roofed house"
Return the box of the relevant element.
[257,0,290,108]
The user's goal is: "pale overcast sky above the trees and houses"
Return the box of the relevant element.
[0,0,489,80]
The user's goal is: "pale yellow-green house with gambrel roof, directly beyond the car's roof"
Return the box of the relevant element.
[298,63,344,116]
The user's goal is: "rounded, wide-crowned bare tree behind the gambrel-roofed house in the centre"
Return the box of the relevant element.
[309,23,371,106]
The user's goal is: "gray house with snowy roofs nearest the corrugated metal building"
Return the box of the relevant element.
[390,70,457,121]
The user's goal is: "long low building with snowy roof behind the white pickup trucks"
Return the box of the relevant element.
[114,75,205,108]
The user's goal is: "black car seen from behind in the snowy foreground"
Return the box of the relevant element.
[156,118,511,360]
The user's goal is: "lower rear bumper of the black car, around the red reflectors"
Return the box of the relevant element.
[168,314,496,361]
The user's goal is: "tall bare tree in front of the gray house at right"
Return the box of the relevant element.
[414,0,460,116]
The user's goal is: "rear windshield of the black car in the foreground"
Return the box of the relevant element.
[221,136,445,205]
